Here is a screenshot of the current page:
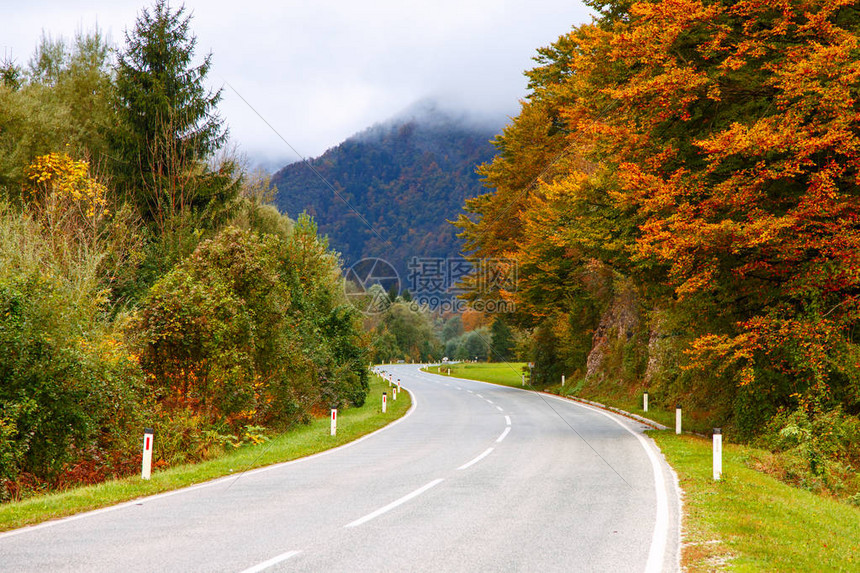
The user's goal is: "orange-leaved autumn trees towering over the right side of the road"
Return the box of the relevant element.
[458,0,860,434]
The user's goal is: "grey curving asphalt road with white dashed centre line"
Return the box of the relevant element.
[0,365,679,573]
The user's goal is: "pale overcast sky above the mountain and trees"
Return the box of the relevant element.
[0,0,590,168]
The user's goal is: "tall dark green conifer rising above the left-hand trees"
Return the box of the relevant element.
[114,0,235,232]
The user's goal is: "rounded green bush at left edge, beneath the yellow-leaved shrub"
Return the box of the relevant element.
[0,274,140,492]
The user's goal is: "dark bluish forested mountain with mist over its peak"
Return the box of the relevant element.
[272,102,501,280]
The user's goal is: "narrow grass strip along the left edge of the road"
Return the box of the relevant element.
[0,376,412,531]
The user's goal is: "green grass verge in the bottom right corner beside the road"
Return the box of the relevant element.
[651,431,860,572]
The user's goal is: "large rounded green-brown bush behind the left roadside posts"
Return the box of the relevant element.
[135,223,367,429]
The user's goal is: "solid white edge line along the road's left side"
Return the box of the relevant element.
[0,387,418,539]
